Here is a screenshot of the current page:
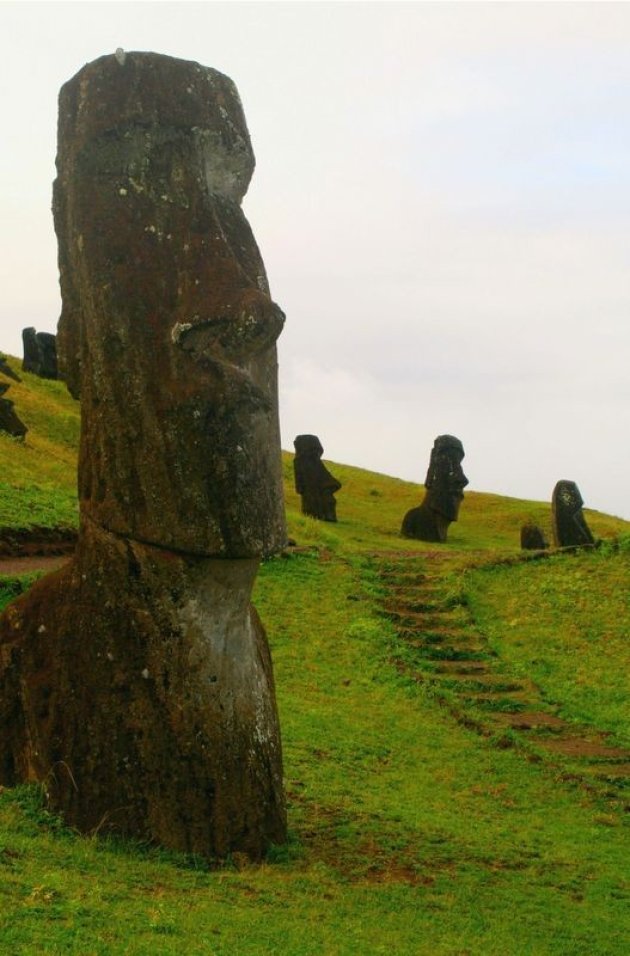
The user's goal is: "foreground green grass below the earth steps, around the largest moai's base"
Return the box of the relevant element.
[0,554,630,956]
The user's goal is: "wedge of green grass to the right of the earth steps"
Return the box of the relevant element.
[466,536,630,746]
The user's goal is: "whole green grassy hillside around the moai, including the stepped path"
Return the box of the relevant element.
[0,354,630,956]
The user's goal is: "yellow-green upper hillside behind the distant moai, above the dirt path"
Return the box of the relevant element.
[0,356,630,550]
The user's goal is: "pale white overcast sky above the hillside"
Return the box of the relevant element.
[0,0,630,518]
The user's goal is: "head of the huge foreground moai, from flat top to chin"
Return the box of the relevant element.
[53,51,286,557]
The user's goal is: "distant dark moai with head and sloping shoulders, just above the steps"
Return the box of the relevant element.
[401,435,468,542]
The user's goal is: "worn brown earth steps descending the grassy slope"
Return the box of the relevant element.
[372,553,630,811]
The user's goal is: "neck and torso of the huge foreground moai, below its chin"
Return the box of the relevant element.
[0,523,284,857]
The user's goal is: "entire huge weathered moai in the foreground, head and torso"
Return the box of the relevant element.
[0,52,286,857]
